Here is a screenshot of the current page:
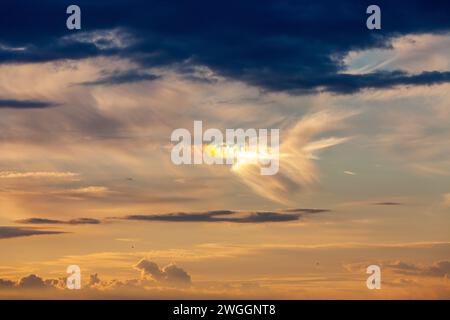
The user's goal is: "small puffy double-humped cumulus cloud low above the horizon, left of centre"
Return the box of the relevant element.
[135,259,191,286]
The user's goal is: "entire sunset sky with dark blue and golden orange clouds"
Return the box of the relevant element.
[0,0,450,299]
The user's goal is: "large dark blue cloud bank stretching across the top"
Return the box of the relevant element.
[0,0,450,93]
